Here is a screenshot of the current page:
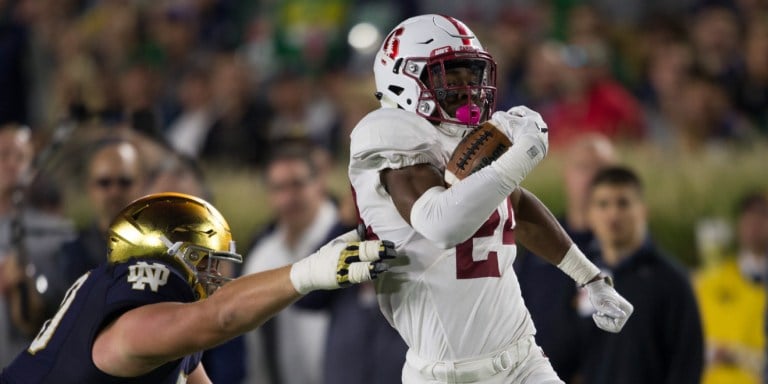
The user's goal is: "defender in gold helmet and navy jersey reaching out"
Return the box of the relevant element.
[0,193,394,384]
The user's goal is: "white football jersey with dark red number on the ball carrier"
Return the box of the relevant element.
[349,108,535,361]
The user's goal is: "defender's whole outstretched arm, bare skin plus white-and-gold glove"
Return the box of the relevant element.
[92,231,394,377]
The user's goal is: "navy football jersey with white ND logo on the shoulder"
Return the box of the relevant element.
[0,259,202,384]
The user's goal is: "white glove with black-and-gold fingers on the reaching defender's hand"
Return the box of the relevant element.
[291,231,396,294]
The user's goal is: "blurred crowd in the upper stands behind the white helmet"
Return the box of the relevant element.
[0,0,768,159]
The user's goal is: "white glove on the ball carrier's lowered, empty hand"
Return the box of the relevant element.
[584,277,635,333]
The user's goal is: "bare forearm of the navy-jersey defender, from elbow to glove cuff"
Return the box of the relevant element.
[120,266,300,364]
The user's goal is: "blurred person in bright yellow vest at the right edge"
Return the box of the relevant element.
[696,193,768,384]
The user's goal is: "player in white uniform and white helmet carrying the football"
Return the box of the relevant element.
[349,15,632,383]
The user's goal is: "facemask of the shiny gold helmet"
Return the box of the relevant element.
[161,236,243,299]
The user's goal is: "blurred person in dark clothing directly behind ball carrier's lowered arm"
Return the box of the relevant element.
[514,134,616,382]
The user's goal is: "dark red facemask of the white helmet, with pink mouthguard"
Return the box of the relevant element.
[406,49,496,128]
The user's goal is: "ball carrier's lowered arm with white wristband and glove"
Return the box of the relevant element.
[511,188,634,332]
